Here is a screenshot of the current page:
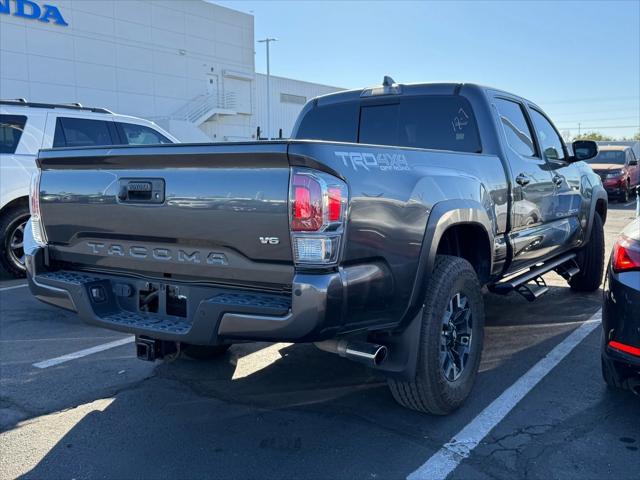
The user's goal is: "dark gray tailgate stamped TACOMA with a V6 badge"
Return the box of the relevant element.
[38,143,293,288]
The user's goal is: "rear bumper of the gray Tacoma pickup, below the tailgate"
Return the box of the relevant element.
[26,244,350,345]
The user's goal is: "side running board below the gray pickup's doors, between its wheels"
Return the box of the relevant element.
[489,253,580,302]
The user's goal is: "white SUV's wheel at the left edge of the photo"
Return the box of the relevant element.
[0,204,29,277]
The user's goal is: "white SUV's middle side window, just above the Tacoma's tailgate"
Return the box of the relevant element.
[53,117,114,147]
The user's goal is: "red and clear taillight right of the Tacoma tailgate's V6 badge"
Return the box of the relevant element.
[289,168,347,265]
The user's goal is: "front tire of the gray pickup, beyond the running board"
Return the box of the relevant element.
[569,213,604,292]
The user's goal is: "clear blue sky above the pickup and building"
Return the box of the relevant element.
[218,0,640,136]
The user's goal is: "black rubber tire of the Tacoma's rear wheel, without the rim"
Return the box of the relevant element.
[388,255,484,415]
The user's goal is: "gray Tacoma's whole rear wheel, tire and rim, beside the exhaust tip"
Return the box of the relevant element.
[388,255,484,415]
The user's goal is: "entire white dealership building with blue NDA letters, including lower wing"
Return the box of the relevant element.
[0,0,340,142]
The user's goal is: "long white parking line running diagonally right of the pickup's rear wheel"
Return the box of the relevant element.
[407,310,602,480]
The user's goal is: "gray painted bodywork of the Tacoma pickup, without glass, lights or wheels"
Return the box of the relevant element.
[28,84,606,343]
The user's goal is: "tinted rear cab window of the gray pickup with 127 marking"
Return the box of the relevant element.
[295,95,482,153]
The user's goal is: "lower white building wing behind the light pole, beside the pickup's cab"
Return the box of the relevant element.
[256,73,344,138]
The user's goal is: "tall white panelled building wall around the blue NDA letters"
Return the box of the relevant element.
[0,0,254,142]
